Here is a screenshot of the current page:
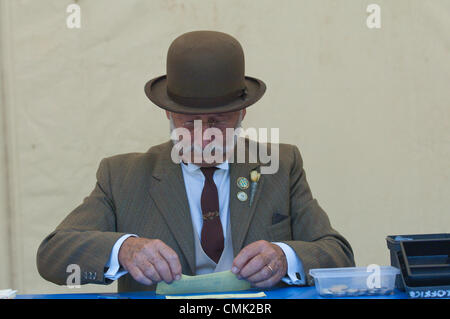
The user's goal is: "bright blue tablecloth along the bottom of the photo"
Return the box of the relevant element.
[16,287,408,299]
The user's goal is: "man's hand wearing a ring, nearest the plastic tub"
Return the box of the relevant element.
[231,240,287,288]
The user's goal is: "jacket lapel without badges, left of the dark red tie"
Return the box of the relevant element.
[149,142,195,274]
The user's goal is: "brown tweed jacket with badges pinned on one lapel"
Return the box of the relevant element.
[37,141,354,292]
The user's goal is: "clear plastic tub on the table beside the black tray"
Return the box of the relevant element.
[309,266,400,297]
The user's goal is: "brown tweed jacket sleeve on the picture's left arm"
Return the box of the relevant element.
[37,159,125,285]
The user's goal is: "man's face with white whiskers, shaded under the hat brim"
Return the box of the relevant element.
[166,109,246,166]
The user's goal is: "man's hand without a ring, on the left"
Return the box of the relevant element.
[119,237,181,285]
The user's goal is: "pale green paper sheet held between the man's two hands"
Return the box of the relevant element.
[156,270,250,295]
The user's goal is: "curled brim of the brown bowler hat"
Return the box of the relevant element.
[144,75,266,114]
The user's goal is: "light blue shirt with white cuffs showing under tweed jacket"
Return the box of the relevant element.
[105,162,305,285]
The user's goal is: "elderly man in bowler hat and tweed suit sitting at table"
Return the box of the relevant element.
[37,31,354,291]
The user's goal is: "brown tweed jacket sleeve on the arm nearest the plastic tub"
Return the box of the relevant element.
[284,146,355,285]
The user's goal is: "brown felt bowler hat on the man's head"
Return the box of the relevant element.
[145,31,266,114]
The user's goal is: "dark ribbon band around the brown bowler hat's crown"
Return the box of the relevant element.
[167,87,247,107]
